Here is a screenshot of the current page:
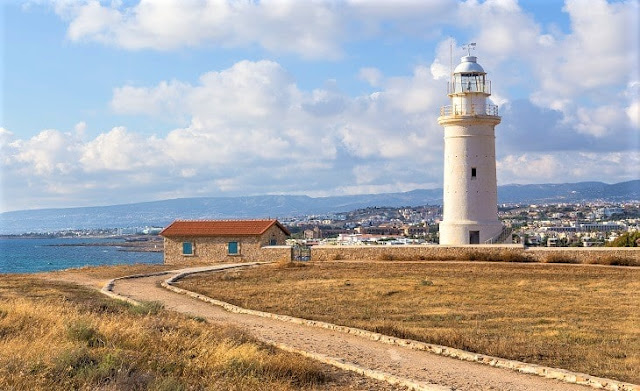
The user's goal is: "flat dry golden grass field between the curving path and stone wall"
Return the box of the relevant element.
[179,262,640,384]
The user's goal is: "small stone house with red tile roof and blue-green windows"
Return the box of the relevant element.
[160,220,291,265]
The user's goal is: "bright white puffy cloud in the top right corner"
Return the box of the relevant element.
[533,0,640,105]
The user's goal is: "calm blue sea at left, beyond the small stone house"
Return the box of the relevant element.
[0,238,163,274]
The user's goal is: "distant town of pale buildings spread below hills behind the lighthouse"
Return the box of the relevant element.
[280,201,640,247]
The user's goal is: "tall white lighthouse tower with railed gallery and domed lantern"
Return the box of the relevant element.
[438,43,510,245]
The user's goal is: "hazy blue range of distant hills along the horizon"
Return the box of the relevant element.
[0,180,640,234]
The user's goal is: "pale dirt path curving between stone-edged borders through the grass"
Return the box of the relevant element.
[109,266,591,391]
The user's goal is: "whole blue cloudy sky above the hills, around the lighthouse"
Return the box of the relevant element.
[0,0,640,212]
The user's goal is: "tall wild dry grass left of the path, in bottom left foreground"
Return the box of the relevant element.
[0,275,390,390]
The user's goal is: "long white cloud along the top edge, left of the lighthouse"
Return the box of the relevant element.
[54,0,456,58]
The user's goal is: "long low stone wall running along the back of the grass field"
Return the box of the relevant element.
[311,245,640,266]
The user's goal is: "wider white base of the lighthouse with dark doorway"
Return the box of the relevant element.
[440,220,502,246]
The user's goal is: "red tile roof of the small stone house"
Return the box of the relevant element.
[160,220,291,237]
